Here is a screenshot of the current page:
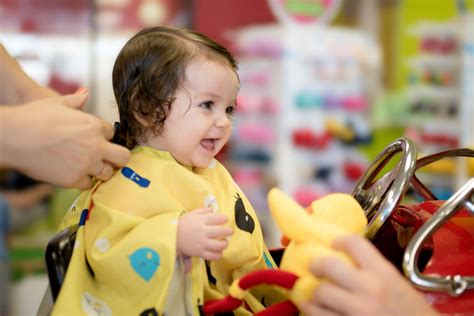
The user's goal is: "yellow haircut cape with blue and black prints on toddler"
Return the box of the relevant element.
[53,147,282,315]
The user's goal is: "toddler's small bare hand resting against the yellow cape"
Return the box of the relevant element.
[176,207,233,260]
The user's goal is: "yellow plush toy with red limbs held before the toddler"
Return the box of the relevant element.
[204,188,367,316]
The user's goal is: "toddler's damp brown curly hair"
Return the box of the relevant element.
[112,26,237,149]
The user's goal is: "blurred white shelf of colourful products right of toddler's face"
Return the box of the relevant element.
[229,1,380,246]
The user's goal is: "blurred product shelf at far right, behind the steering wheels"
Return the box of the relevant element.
[405,8,474,199]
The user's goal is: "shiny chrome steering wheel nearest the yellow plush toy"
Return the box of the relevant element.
[352,137,417,239]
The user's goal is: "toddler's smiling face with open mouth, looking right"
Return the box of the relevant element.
[147,59,239,168]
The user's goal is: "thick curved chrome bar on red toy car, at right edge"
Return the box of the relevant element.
[403,178,474,296]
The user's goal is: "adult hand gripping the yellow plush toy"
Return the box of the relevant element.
[300,235,436,316]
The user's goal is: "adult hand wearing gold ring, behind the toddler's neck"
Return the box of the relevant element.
[0,92,130,189]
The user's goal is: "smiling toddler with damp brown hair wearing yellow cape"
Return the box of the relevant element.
[53,26,283,315]
